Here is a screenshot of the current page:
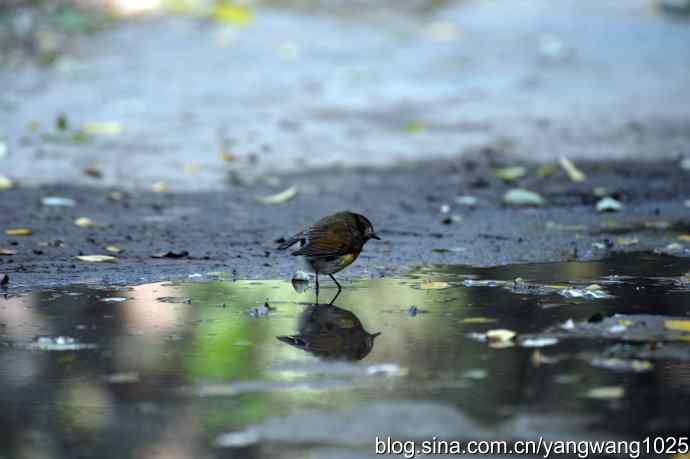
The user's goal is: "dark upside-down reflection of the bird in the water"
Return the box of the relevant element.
[277,298,381,361]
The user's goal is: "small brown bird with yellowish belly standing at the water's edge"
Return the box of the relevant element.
[278,212,381,295]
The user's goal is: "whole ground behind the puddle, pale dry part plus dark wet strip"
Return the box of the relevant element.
[0,1,690,289]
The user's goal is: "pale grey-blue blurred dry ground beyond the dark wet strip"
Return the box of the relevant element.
[0,0,690,190]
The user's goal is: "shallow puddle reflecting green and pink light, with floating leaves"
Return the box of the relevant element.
[0,253,690,457]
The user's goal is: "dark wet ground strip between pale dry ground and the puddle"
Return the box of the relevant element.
[0,155,690,289]
